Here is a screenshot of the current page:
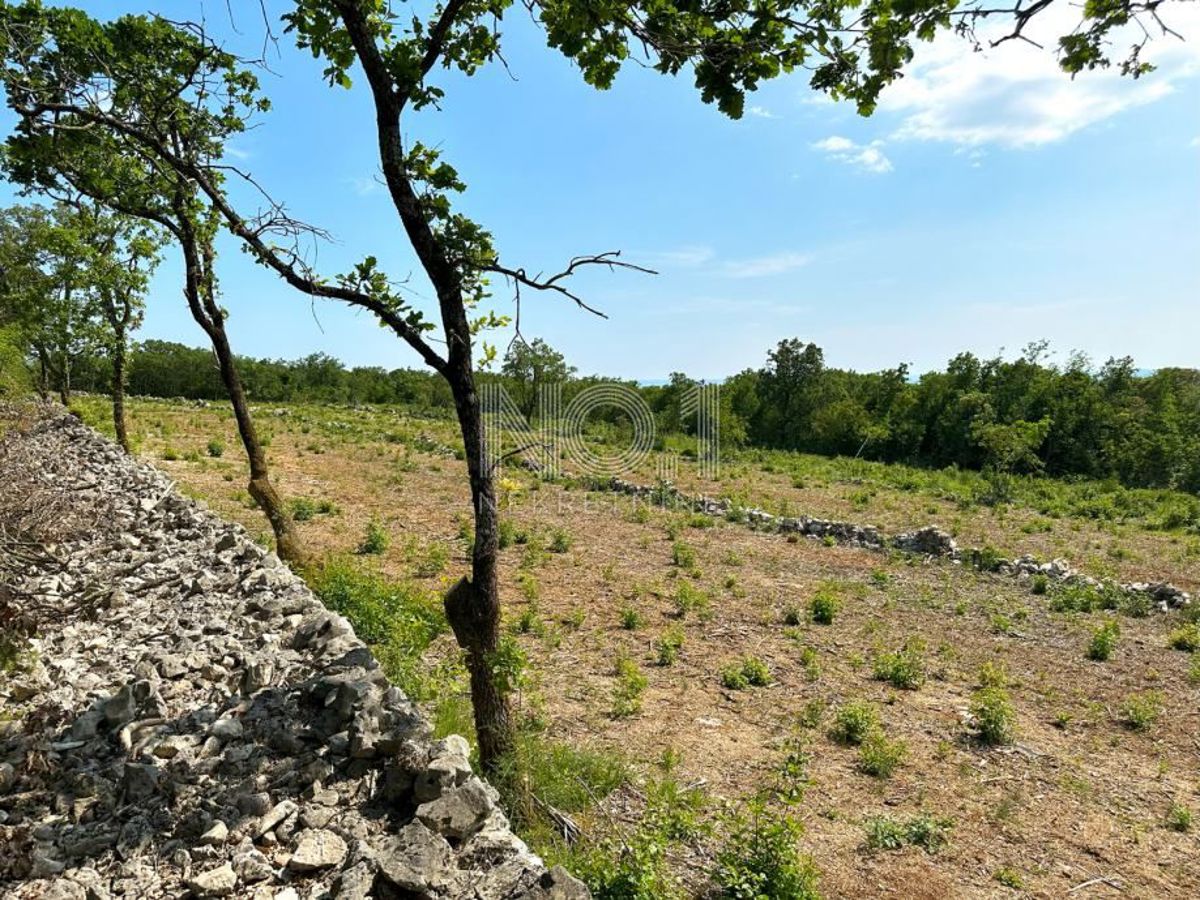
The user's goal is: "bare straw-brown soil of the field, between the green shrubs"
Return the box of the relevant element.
[75,402,1200,898]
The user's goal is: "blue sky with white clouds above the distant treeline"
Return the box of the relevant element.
[0,0,1200,380]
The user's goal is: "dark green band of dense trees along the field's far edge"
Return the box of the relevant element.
[51,340,1200,491]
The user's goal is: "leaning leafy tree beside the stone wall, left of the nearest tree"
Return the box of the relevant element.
[0,12,304,562]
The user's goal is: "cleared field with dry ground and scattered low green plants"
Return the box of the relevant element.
[70,398,1200,898]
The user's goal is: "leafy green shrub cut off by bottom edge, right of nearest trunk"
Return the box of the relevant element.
[713,802,821,900]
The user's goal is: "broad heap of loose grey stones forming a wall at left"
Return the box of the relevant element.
[0,415,588,900]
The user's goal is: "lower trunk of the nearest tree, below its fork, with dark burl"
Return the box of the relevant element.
[445,355,515,774]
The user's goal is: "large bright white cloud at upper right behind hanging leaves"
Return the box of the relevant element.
[880,5,1200,148]
